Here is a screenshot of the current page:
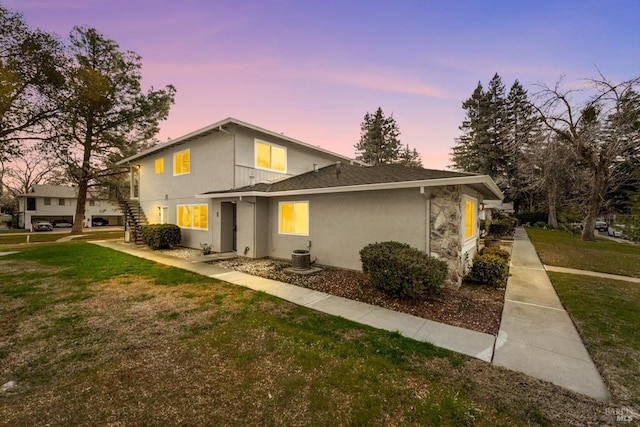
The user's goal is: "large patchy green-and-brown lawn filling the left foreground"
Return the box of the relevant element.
[0,242,616,426]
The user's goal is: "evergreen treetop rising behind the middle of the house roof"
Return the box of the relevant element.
[355,107,422,167]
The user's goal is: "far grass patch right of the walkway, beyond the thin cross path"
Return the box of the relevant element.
[526,228,640,277]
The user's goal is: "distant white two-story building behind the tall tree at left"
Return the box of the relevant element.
[18,185,124,228]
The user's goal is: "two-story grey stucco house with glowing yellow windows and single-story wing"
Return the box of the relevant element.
[121,118,502,286]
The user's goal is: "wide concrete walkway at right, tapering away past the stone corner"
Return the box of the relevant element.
[493,228,609,399]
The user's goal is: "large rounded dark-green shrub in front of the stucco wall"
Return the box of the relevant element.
[360,242,447,299]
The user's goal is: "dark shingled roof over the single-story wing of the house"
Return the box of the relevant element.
[200,162,500,198]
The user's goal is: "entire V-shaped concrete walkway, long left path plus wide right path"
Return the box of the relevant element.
[93,236,609,399]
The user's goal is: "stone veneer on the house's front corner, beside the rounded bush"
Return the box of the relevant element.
[429,185,463,288]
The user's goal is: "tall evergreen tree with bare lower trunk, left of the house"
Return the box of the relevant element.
[48,28,175,233]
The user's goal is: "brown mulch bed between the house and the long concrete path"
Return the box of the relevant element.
[208,258,505,335]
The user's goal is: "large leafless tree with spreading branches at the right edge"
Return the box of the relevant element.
[536,74,640,240]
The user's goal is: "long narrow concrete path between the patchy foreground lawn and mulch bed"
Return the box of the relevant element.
[92,241,495,362]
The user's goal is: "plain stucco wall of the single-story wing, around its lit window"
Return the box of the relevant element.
[269,189,427,270]
